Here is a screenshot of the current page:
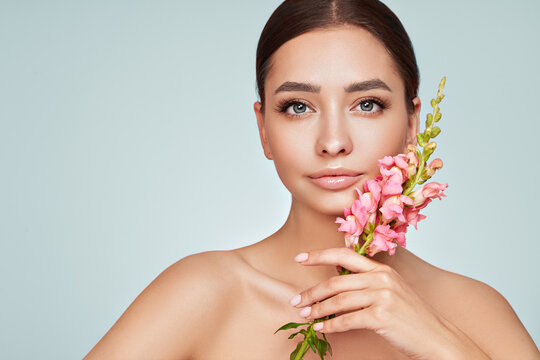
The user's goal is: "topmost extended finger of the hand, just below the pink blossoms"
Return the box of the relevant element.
[297,247,383,272]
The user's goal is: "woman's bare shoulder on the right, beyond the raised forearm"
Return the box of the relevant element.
[424,265,540,359]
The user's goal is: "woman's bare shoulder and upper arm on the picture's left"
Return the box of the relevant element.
[85,251,242,359]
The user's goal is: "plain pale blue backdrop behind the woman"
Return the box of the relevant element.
[0,0,540,359]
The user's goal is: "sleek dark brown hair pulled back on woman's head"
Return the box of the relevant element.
[256,0,420,113]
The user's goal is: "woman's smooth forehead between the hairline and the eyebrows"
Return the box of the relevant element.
[266,26,403,93]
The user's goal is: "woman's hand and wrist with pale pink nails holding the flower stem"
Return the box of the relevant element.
[291,248,488,359]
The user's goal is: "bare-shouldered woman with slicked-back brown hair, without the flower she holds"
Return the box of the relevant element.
[86,0,540,359]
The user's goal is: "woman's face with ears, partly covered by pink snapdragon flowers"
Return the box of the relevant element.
[254,26,420,216]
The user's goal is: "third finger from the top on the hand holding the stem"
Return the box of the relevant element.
[301,290,375,320]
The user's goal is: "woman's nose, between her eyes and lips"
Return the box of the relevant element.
[316,110,353,157]
